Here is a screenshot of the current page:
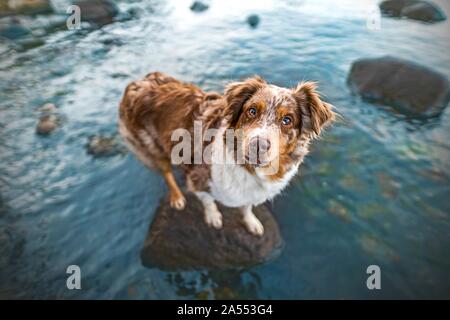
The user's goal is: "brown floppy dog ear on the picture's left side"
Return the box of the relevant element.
[225,76,267,126]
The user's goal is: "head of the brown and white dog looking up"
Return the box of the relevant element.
[225,77,335,178]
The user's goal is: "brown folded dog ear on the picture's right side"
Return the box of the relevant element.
[293,81,335,138]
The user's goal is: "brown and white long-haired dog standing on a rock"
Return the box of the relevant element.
[119,72,336,236]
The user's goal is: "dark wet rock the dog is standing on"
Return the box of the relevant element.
[141,192,283,270]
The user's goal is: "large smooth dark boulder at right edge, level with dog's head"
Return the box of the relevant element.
[348,56,450,116]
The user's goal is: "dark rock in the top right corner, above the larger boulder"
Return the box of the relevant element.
[380,0,446,22]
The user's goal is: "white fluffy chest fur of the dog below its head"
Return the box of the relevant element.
[210,130,300,207]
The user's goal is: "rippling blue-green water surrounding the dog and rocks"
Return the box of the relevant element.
[0,0,450,299]
